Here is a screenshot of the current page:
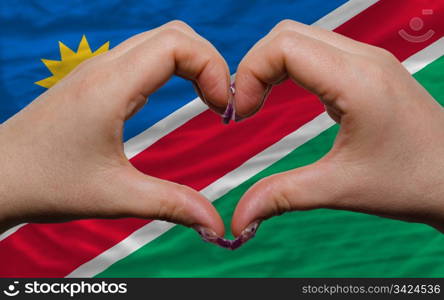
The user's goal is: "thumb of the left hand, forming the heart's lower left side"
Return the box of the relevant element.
[103,167,224,236]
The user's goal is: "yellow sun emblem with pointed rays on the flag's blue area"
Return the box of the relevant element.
[35,35,109,88]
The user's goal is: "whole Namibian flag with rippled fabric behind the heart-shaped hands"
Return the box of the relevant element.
[0,0,444,277]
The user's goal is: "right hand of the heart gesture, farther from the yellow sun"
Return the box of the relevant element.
[232,21,444,236]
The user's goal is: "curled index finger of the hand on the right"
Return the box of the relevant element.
[235,23,354,118]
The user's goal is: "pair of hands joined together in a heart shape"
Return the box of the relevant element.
[0,21,444,246]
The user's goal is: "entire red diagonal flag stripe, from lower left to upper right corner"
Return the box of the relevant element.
[0,0,444,277]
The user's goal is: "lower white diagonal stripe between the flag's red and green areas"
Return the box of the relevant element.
[67,38,444,277]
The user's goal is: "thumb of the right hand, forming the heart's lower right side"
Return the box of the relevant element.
[231,161,346,236]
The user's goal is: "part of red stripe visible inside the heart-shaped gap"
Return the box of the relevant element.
[131,81,324,190]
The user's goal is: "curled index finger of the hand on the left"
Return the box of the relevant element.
[95,21,230,116]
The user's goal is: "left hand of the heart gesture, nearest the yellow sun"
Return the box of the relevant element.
[0,21,230,235]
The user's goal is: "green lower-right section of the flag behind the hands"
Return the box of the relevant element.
[98,57,444,277]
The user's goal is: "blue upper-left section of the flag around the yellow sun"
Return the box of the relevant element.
[0,0,346,140]
